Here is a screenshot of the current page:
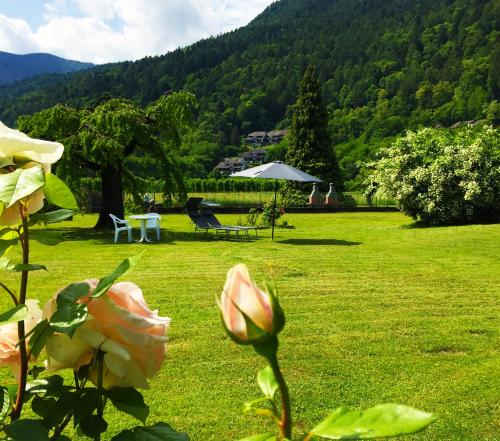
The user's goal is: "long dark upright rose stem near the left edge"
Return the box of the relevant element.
[11,213,30,420]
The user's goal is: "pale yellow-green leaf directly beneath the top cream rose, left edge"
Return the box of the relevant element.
[0,165,45,208]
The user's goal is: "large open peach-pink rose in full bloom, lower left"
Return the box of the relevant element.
[44,279,170,388]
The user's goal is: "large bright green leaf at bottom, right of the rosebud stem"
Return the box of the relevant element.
[311,403,436,439]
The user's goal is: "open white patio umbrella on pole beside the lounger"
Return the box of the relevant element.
[229,161,323,240]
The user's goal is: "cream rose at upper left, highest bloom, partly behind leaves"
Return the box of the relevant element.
[0,122,64,225]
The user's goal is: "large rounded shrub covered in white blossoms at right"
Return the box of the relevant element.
[370,126,500,225]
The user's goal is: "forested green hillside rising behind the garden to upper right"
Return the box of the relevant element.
[0,0,500,182]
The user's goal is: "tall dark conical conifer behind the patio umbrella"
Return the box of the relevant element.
[286,65,341,188]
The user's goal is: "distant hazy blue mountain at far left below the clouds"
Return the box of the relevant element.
[0,51,94,85]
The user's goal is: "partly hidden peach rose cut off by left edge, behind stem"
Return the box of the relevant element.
[0,300,42,380]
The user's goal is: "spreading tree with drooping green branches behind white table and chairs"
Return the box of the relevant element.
[18,92,196,228]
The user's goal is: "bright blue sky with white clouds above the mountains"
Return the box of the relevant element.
[0,0,273,64]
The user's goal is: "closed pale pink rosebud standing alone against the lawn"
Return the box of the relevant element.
[220,263,284,344]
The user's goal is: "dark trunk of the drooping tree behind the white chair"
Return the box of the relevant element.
[94,164,125,229]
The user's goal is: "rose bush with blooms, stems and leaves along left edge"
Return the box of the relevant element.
[0,123,189,441]
